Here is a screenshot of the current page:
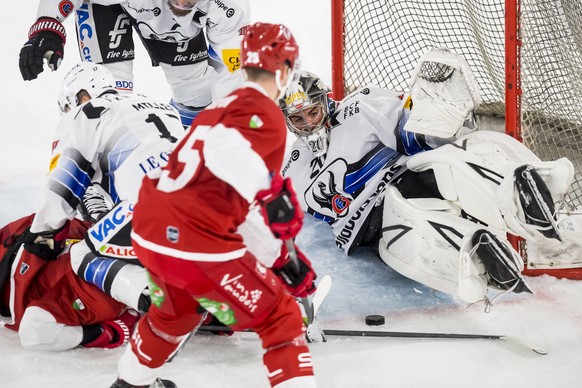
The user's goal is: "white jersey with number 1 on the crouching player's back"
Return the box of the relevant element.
[31,93,185,233]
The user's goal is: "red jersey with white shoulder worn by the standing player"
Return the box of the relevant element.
[132,82,286,261]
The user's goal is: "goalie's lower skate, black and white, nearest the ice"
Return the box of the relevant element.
[471,229,533,293]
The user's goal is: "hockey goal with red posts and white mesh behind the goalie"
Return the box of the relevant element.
[332,0,582,278]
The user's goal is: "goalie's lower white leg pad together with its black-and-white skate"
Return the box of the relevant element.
[379,187,529,303]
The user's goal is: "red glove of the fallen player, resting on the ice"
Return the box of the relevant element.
[83,309,140,349]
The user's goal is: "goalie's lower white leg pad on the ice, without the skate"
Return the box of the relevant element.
[379,187,487,303]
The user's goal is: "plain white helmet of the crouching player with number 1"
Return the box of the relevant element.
[58,62,116,113]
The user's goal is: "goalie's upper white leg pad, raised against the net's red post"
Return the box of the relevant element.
[406,131,574,238]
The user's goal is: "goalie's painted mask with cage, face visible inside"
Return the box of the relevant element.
[279,71,333,156]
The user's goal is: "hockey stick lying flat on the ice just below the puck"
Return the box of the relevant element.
[323,329,548,356]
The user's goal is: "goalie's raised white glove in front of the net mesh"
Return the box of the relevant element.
[404,48,481,138]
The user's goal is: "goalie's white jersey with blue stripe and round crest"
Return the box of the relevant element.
[282,86,427,254]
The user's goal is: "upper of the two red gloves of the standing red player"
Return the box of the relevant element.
[256,174,303,240]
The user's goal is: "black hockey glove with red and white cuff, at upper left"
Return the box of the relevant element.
[19,17,67,81]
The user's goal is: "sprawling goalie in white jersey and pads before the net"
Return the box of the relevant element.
[280,49,573,302]
